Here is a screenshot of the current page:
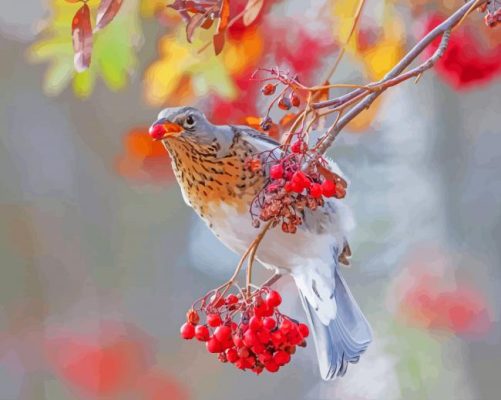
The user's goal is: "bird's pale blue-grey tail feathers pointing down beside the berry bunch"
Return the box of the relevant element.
[295,268,372,380]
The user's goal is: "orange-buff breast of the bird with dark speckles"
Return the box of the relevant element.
[165,137,265,220]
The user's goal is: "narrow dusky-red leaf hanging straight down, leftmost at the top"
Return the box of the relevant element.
[71,4,92,72]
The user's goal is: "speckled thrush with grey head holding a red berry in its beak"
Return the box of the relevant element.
[150,106,373,380]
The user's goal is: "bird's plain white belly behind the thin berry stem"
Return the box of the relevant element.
[205,205,344,272]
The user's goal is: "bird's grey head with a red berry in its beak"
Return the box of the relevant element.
[150,107,216,144]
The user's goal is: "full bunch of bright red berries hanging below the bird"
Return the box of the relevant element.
[181,288,309,374]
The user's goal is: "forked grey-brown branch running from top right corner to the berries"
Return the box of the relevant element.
[312,0,488,159]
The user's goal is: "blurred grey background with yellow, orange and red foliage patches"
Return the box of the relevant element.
[0,0,501,400]
